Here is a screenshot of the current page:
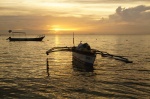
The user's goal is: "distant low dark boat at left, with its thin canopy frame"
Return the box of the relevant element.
[7,30,45,41]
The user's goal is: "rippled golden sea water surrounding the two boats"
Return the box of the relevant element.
[0,35,150,99]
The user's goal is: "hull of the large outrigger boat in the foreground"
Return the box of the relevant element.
[72,52,96,71]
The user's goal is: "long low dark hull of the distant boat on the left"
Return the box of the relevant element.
[8,36,44,41]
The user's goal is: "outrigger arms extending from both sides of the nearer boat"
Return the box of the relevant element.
[46,46,133,63]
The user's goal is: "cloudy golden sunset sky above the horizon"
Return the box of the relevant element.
[0,0,150,34]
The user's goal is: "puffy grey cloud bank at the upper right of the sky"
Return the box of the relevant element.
[109,5,150,22]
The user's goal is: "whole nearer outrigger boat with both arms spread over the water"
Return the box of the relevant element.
[46,42,132,71]
